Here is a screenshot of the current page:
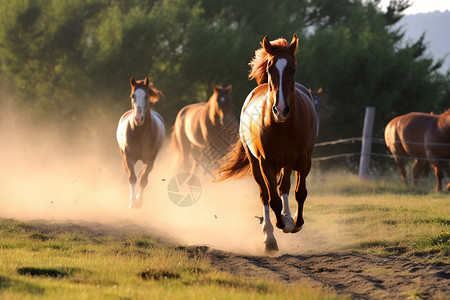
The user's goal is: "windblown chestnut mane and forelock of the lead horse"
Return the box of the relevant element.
[248,38,295,85]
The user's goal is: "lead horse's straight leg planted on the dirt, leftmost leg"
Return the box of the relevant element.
[250,155,278,254]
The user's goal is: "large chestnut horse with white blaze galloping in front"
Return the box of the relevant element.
[219,35,317,253]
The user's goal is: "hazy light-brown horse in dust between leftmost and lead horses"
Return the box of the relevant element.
[172,85,237,173]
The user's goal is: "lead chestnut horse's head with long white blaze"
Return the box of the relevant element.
[261,34,298,122]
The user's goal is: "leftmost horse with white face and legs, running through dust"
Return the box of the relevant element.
[116,77,165,208]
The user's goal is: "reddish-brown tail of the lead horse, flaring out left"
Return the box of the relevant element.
[216,139,250,181]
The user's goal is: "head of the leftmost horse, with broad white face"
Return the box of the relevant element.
[130,76,161,126]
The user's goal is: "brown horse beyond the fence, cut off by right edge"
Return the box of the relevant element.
[384,109,450,191]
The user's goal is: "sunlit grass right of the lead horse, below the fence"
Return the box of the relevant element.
[304,174,450,258]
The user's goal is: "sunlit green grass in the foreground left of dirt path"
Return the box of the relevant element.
[0,219,339,299]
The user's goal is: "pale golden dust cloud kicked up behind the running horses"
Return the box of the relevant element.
[0,104,334,255]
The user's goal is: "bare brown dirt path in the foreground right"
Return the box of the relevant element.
[182,247,450,299]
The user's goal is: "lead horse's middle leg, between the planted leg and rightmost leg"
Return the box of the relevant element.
[260,159,294,232]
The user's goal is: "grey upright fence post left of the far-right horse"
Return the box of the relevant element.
[359,106,375,180]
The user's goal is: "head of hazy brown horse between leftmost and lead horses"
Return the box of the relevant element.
[209,85,234,126]
